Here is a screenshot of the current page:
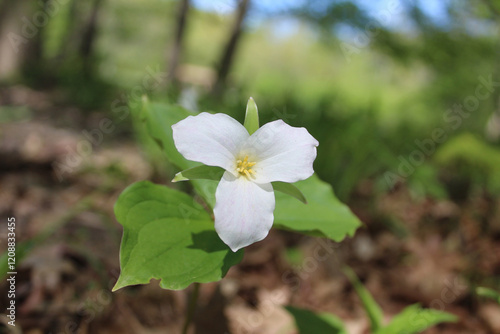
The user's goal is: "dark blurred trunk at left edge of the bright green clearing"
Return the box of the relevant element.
[80,0,103,76]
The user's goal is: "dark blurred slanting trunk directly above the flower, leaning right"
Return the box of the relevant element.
[212,0,250,96]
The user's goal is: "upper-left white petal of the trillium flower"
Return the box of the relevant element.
[172,112,249,171]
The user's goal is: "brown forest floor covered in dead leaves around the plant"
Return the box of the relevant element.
[0,86,500,334]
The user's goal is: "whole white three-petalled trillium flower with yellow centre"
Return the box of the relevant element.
[172,112,319,252]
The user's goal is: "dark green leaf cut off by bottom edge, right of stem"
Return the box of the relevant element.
[285,306,347,334]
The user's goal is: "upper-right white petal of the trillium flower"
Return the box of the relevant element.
[240,120,319,183]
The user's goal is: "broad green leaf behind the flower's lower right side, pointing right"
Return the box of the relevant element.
[273,175,361,242]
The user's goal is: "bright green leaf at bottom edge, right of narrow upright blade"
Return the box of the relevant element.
[375,304,457,334]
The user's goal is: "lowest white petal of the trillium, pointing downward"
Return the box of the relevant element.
[214,172,275,252]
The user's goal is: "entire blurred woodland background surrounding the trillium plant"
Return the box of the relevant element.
[0,0,500,334]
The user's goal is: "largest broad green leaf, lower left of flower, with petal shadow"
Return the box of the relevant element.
[113,181,243,290]
